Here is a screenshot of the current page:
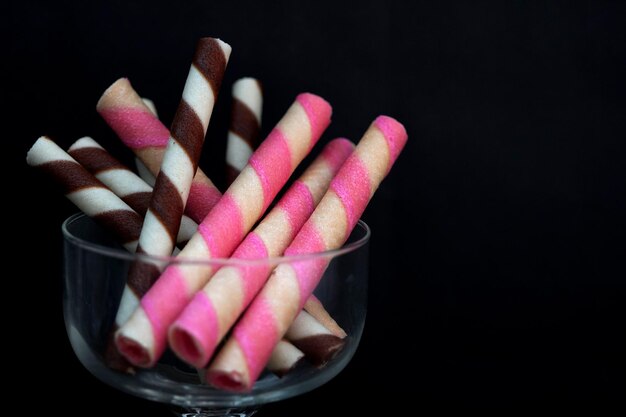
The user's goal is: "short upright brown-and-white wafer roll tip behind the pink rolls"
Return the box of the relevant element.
[226,77,263,185]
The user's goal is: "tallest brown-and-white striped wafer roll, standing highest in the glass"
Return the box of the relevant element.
[122,38,230,308]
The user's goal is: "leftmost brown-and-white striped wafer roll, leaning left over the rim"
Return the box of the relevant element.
[26,136,142,252]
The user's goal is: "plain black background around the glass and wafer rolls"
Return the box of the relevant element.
[7,1,626,416]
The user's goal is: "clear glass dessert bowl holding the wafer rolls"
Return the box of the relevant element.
[62,214,370,416]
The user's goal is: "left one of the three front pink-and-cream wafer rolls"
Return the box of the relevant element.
[116,94,331,366]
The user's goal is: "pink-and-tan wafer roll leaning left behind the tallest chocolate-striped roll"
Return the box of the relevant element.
[96,75,223,223]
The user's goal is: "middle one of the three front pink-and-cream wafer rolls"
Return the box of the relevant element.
[169,139,354,368]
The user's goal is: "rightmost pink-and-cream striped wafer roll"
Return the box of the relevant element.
[207,116,407,391]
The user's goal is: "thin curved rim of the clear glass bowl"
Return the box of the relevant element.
[61,212,372,265]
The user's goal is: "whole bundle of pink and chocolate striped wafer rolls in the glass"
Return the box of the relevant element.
[27,38,407,391]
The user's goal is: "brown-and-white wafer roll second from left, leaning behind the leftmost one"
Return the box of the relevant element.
[67,136,198,243]
